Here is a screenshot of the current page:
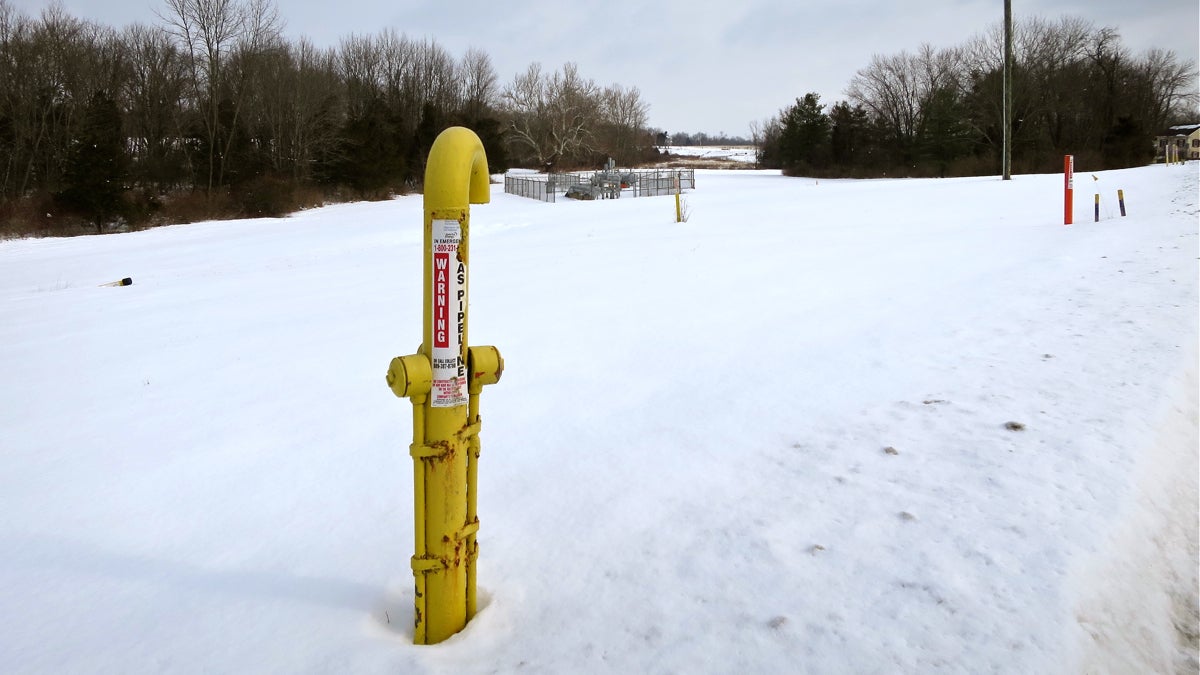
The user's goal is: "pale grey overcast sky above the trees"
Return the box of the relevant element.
[8,0,1200,136]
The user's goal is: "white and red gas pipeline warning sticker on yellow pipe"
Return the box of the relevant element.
[430,220,467,408]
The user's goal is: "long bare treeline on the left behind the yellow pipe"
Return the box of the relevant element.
[0,0,654,233]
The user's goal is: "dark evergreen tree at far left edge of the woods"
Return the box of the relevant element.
[58,91,127,234]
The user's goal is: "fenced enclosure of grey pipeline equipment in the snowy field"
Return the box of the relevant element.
[504,168,696,202]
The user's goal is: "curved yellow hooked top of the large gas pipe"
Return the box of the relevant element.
[425,126,492,210]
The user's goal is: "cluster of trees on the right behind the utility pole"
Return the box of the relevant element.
[752,17,1196,177]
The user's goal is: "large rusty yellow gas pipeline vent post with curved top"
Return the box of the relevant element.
[388,126,504,645]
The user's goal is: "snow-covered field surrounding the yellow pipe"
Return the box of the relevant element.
[0,163,1200,674]
